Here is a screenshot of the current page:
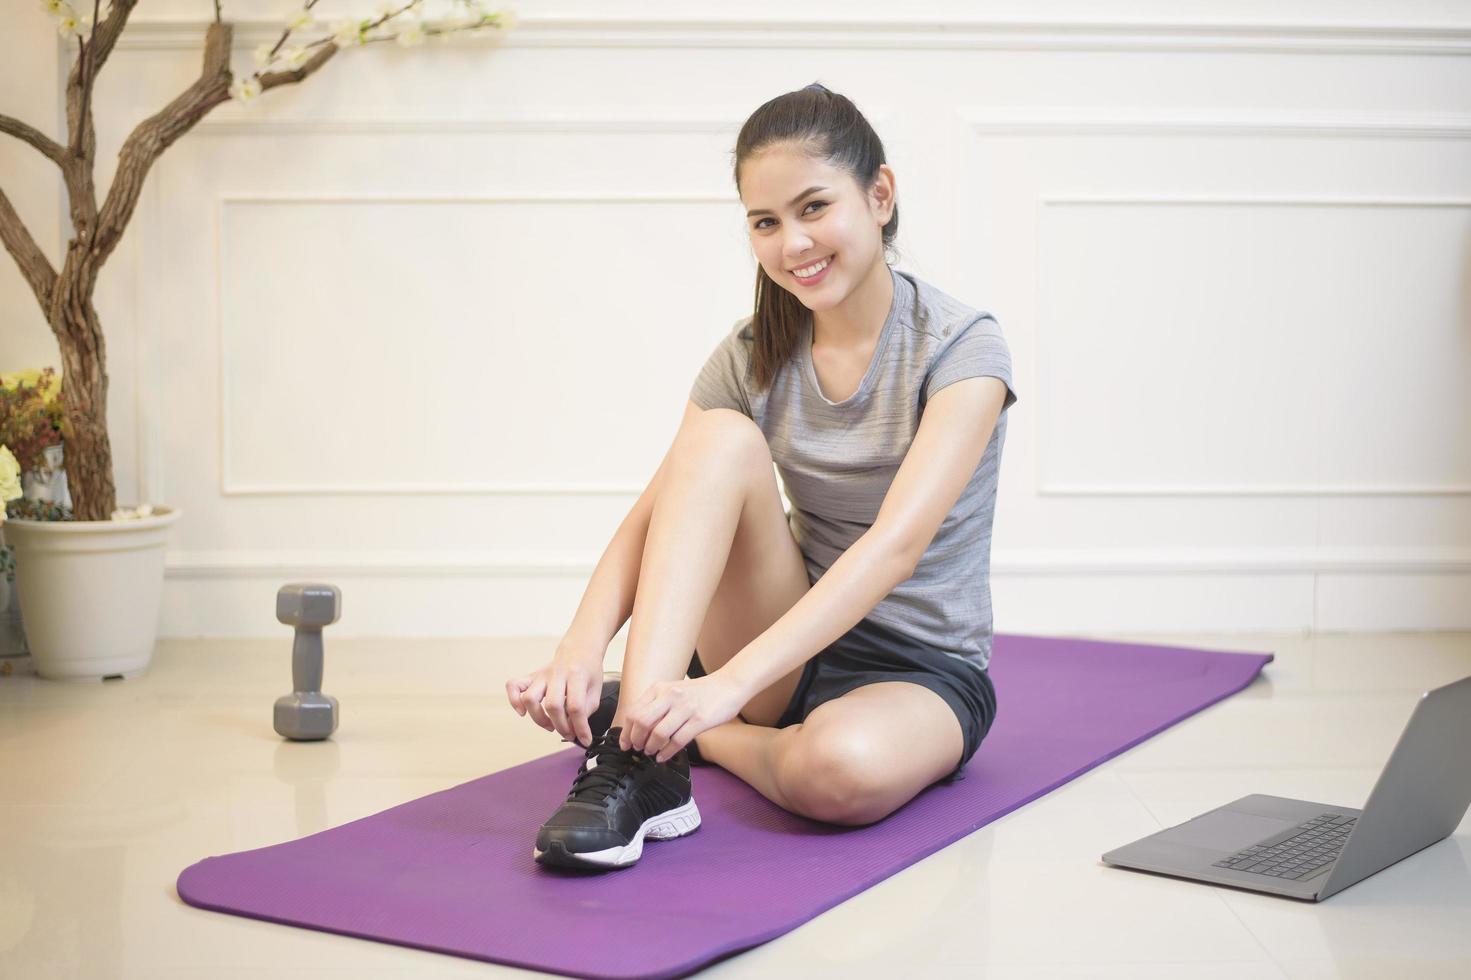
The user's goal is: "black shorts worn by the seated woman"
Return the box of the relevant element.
[690,619,996,783]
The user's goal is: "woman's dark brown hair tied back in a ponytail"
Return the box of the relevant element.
[734,82,899,390]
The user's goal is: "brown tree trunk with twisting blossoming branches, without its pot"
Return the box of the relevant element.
[0,0,515,521]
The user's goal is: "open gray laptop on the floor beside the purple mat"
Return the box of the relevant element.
[1103,677,1471,902]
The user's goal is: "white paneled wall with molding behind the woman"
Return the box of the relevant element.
[0,0,1471,636]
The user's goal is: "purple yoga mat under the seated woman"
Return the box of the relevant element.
[178,634,1272,977]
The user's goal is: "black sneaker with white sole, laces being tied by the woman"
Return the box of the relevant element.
[533,725,700,871]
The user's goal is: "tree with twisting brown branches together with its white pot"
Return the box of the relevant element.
[0,0,515,680]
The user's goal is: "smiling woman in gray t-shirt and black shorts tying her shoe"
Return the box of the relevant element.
[506,84,1016,868]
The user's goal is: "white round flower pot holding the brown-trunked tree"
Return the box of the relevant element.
[4,508,179,680]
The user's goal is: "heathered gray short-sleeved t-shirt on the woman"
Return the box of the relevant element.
[690,261,1016,670]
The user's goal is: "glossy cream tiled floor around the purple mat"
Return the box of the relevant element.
[0,631,1471,980]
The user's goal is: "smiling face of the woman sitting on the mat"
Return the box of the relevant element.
[740,144,893,310]
